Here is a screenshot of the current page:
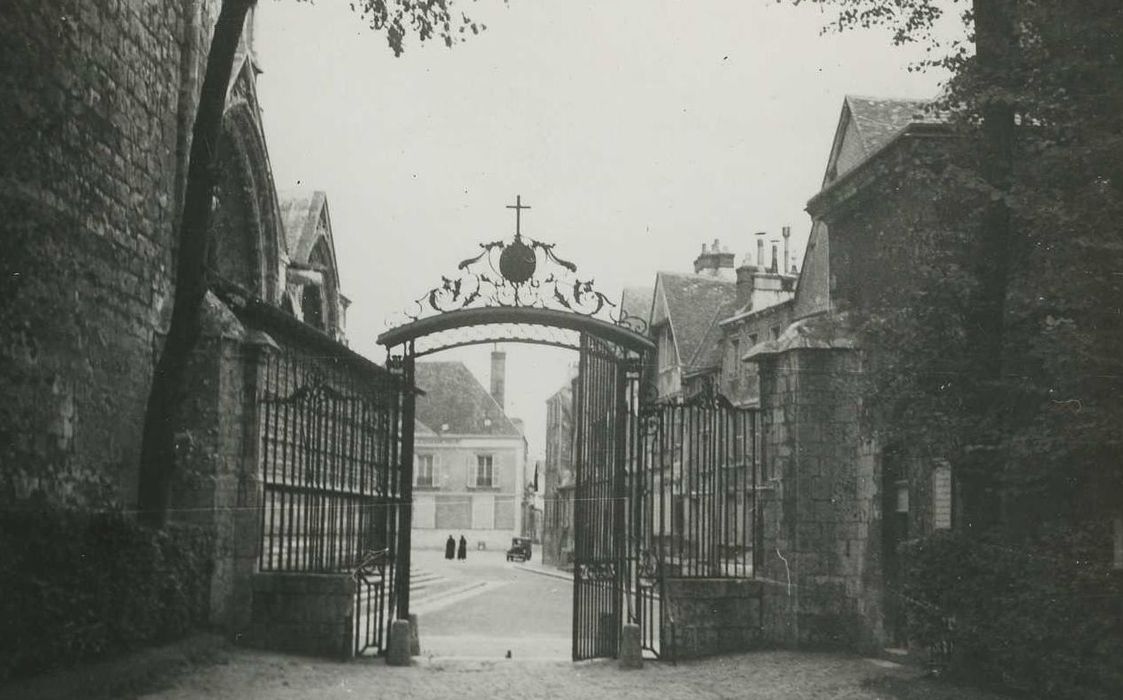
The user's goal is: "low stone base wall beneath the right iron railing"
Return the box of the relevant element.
[663,579,763,660]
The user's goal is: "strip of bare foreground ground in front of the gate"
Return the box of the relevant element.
[135,649,997,700]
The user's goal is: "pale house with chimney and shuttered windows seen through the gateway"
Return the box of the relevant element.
[413,351,527,549]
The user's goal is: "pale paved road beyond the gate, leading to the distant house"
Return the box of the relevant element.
[412,551,573,661]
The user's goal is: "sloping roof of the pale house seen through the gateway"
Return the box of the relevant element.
[414,362,522,437]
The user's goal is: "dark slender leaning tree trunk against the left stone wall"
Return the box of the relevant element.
[138,0,255,527]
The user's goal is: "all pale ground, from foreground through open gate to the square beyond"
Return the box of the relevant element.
[127,551,1006,700]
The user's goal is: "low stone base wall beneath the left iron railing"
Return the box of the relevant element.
[248,573,355,658]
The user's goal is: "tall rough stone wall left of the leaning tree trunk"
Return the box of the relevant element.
[0,0,214,507]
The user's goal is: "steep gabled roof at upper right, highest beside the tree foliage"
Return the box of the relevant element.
[823,94,943,188]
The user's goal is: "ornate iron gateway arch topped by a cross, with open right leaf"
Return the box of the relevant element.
[378,201,655,660]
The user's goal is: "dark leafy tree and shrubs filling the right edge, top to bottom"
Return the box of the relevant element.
[808,0,1123,698]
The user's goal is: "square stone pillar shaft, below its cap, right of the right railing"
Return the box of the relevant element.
[760,349,885,648]
